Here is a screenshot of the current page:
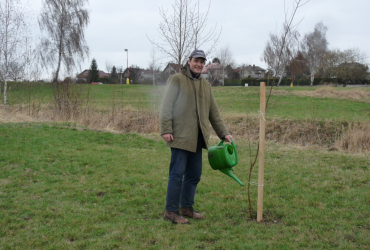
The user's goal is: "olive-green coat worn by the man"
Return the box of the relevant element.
[160,65,229,152]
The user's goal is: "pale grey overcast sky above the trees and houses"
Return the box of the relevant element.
[28,0,370,75]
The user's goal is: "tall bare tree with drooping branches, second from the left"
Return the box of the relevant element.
[39,0,89,81]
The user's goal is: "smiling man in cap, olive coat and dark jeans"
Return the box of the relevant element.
[160,50,232,224]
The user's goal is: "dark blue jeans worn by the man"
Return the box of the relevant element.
[166,130,204,212]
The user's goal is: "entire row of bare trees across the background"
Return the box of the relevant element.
[0,0,367,108]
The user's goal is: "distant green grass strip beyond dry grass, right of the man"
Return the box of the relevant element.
[213,87,370,121]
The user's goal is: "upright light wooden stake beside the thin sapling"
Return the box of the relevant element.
[257,82,266,222]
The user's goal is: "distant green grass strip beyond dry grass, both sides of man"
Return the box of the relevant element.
[4,84,370,121]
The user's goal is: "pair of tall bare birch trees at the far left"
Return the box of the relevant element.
[0,0,89,106]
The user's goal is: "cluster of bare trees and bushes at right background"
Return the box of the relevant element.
[261,19,369,86]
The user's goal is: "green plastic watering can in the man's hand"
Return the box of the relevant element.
[208,140,244,186]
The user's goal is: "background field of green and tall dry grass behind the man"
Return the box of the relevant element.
[0,84,370,152]
